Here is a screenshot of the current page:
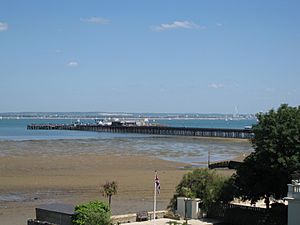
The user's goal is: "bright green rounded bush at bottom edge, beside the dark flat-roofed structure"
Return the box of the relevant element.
[73,201,111,225]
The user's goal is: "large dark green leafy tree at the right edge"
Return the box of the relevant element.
[236,104,300,207]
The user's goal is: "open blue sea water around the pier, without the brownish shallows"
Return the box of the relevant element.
[0,119,256,140]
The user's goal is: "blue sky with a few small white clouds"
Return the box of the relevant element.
[0,0,300,113]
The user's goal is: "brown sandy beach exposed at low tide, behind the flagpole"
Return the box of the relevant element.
[0,140,248,225]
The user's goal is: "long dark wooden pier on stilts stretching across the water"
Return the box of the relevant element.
[27,124,253,139]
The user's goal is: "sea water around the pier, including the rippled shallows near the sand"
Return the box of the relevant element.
[0,119,255,164]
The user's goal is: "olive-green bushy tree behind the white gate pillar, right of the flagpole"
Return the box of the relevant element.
[169,169,233,210]
